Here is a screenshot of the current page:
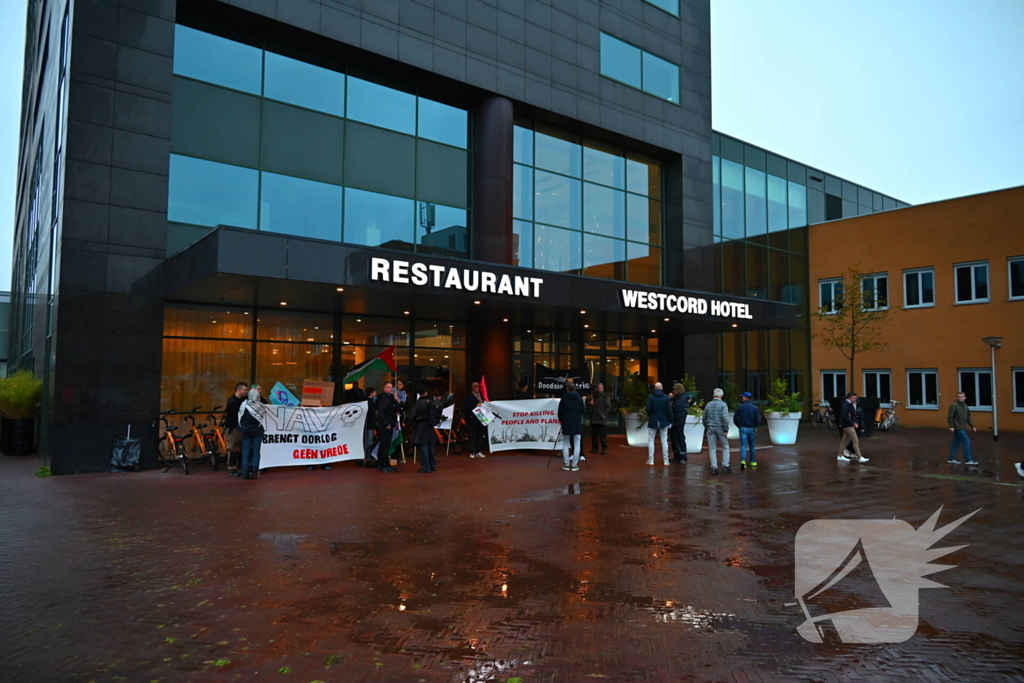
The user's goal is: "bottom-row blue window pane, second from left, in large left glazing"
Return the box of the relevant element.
[259,172,342,242]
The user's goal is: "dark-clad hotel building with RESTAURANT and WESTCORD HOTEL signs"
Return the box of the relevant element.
[9,0,892,472]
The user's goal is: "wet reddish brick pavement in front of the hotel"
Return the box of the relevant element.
[0,427,1024,683]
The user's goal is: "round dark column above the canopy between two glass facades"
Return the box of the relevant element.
[471,96,514,264]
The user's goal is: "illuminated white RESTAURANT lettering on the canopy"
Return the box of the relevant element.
[370,257,544,299]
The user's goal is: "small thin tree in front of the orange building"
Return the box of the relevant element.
[815,263,889,391]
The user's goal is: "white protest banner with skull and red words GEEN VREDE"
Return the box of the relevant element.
[259,401,367,468]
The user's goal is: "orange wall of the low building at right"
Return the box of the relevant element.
[809,187,1024,432]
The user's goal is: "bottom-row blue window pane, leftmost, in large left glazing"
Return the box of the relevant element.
[167,155,259,229]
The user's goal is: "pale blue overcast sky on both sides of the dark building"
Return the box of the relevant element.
[0,0,1024,290]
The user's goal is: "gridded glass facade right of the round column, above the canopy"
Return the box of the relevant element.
[512,123,664,285]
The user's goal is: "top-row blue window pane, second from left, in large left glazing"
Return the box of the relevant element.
[263,52,345,116]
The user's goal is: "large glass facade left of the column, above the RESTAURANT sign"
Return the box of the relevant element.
[167,26,470,257]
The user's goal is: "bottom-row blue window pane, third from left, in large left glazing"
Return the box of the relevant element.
[345,187,415,250]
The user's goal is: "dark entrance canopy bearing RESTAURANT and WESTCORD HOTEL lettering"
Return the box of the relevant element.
[142,227,797,335]
